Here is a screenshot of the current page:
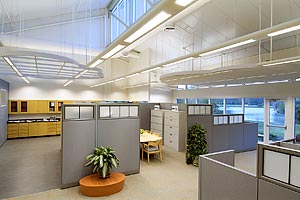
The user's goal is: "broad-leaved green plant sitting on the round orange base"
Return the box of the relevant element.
[84,146,120,179]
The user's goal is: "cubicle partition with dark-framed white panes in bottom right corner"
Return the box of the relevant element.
[257,143,300,200]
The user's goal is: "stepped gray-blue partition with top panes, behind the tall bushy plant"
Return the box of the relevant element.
[187,104,258,153]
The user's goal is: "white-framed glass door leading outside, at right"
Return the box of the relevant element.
[264,99,287,142]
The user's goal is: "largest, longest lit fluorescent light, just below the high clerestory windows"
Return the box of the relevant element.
[124,11,171,43]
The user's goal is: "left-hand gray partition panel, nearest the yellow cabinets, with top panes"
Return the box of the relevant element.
[61,104,96,188]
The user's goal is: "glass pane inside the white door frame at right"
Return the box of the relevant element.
[269,100,285,141]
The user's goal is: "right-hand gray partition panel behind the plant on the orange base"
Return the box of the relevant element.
[97,104,140,175]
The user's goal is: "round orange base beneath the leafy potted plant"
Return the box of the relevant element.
[79,172,125,197]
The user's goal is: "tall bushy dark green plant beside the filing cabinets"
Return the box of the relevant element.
[186,124,208,165]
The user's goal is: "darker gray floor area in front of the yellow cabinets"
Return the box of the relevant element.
[0,136,61,199]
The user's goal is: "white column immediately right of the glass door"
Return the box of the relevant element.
[284,97,295,139]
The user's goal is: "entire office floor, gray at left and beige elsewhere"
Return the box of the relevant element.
[0,137,255,200]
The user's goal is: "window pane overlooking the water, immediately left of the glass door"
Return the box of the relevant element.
[244,98,265,142]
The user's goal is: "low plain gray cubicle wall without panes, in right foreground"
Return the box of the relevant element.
[198,151,257,200]
